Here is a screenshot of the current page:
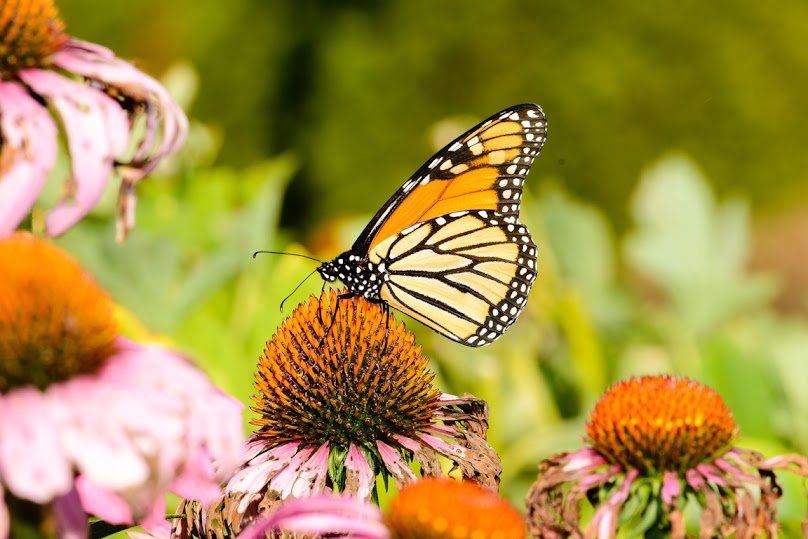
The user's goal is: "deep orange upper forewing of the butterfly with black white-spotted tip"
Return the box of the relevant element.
[352,104,547,255]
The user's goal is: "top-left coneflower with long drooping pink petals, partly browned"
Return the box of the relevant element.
[0,0,188,241]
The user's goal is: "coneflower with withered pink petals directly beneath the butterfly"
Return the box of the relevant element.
[174,291,501,537]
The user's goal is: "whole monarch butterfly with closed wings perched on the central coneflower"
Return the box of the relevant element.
[317,104,547,346]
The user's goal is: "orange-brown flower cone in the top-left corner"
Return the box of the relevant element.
[0,0,68,75]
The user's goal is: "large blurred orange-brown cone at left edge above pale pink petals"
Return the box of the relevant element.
[0,232,117,393]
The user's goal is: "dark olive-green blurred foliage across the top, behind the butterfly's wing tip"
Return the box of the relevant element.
[58,0,808,230]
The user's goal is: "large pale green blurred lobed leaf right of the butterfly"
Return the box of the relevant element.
[624,155,776,333]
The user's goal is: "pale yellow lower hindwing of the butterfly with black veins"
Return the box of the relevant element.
[369,210,536,346]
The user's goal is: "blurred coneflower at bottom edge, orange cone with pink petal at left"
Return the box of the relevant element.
[238,478,525,539]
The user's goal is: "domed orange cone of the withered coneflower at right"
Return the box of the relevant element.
[586,376,738,474]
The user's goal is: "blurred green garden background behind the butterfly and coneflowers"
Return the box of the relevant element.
[57,0,808,530]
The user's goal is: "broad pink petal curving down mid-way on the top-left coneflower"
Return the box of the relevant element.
[18,69,130,236]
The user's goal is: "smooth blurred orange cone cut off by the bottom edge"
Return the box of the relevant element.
[385,479,525,539]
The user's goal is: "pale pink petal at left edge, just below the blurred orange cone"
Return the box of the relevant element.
[0,387,73,504]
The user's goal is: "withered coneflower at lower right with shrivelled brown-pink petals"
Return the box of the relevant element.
[527,376,808,539]
